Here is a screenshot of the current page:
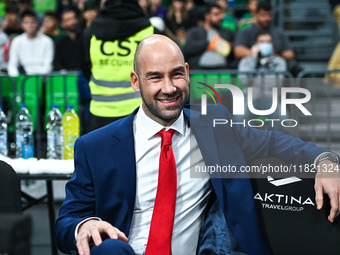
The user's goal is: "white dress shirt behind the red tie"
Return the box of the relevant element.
[128,107,211,255]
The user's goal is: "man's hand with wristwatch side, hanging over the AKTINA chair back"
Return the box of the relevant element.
[314,160,340,222]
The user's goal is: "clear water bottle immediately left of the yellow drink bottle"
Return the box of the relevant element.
[46,105,64,159]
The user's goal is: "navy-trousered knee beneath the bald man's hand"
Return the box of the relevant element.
[91,239,135,255]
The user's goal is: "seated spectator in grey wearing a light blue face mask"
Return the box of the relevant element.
[238,30,287,126]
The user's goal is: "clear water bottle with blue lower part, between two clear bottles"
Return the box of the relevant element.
[15,105,34,159]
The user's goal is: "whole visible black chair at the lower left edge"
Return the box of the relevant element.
[0,161,32,255]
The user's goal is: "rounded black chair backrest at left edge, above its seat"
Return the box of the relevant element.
[0,161,22,213]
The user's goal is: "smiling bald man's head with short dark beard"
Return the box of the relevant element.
[131,35,189,126]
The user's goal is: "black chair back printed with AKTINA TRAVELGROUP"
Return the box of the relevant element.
[248,158,340,255]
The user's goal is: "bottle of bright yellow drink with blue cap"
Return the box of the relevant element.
[63,105,79,159]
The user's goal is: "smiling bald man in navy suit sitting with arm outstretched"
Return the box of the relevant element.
[56,35,340,255]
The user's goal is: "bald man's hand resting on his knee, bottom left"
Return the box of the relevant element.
[77,220,128,255]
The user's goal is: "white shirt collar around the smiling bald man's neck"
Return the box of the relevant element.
[136,103,186,140]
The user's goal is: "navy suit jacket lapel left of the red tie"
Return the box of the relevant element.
[112,108,138,223]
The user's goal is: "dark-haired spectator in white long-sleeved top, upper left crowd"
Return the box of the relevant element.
[7,10,54,76]
